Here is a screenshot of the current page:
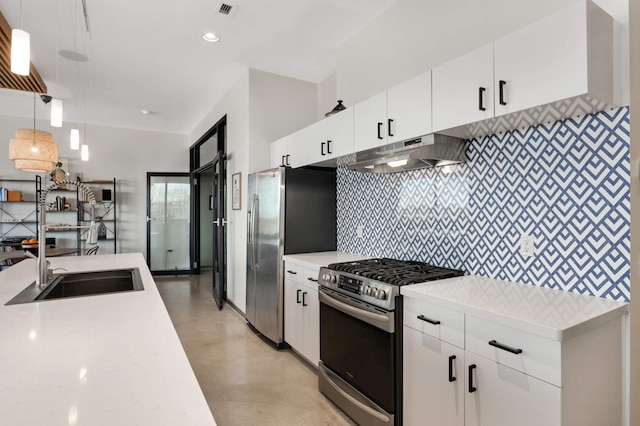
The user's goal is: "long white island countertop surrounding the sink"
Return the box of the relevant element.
[0,253,215,426]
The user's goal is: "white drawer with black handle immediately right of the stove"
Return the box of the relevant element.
[402,297,464,348]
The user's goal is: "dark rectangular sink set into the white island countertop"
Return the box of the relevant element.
[6,268,144,305]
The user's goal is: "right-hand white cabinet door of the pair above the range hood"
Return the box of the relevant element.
[386,71,432,143]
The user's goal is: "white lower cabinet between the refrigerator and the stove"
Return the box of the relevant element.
[284,262,320,367]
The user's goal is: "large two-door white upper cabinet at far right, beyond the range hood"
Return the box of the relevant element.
[433,0,617,137]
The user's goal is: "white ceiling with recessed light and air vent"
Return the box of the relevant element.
[0,0,396,134]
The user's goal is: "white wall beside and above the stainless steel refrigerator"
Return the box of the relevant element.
[189,70,317,312]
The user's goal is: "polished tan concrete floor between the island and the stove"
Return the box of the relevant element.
[155,275,354,426]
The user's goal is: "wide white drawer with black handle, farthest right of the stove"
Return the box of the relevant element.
[465,315,562,386]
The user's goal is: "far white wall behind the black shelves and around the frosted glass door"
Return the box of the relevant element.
[0,116,189,253]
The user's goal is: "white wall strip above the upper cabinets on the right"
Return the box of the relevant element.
[337,0,627,105]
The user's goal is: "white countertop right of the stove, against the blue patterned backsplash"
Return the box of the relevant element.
[400,275,629,341]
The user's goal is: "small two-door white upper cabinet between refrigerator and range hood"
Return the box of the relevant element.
[303,108,354,164]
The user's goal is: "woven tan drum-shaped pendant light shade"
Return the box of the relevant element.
[9,129,58,172]
